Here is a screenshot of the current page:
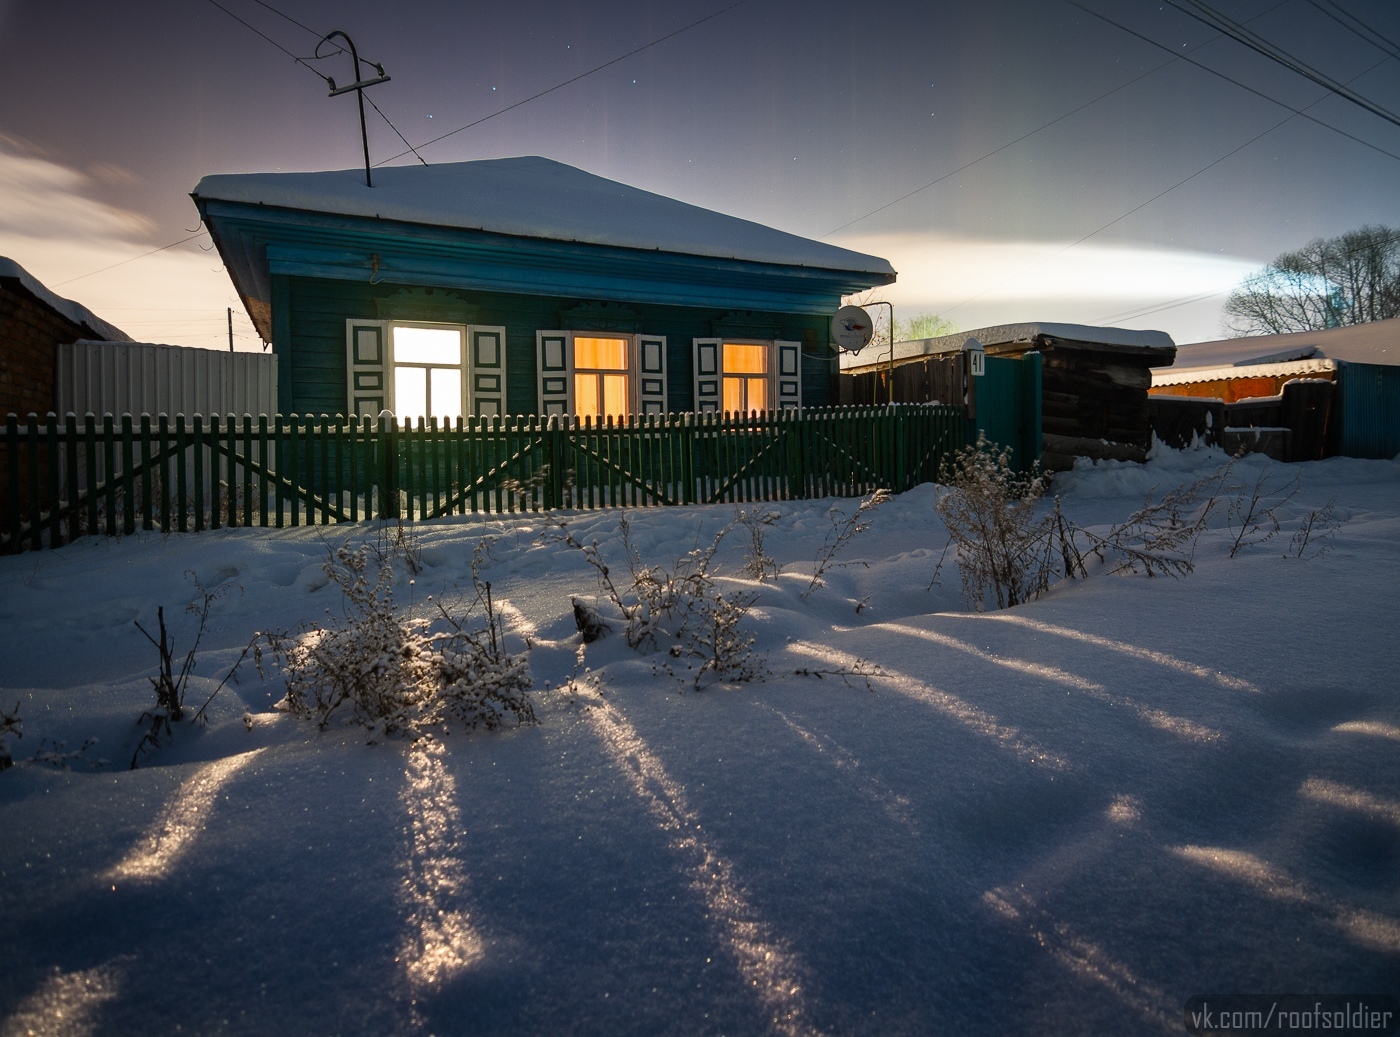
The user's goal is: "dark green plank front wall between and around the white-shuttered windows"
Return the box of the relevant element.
[273,276,836,414]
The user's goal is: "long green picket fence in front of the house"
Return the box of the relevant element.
[0,404,966,551]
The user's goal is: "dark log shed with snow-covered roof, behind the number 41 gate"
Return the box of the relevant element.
[841,323,1176,470]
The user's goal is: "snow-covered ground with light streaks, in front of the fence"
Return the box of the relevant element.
[0,453,1400,1037]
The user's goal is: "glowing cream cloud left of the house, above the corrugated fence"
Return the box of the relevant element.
[0,134,260,348]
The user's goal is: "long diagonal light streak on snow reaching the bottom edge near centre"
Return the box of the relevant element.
[584,701,819,1037]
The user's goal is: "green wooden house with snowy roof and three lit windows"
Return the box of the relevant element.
[193,158,895,420]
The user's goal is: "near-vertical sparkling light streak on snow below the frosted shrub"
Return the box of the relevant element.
[399,740,483,988]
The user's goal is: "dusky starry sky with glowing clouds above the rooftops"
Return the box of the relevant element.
[0,0,1400,348]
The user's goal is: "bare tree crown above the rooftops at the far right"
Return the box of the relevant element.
[1224,225,1400,334]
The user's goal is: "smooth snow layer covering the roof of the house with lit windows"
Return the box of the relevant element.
[195,155,895,277]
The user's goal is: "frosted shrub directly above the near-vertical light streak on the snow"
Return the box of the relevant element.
[265,546,535,739]
